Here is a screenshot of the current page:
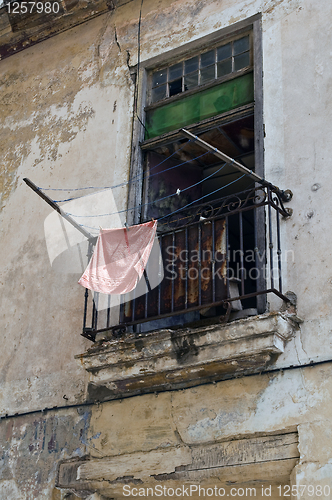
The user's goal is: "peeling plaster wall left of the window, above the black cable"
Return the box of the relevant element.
[0,15,133,413]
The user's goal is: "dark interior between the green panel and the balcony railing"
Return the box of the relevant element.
[144,115,255,220]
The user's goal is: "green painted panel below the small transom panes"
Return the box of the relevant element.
[145,73,254,139]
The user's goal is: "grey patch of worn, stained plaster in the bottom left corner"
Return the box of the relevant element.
[0,411,90,500]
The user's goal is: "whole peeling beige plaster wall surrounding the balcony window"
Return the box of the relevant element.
[0,0,332,499]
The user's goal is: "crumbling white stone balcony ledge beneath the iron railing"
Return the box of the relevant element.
[76,313,295,401]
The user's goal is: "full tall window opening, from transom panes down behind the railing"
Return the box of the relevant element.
[122,27,256,331]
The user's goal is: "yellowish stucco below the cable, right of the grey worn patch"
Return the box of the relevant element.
[84,364,332,498]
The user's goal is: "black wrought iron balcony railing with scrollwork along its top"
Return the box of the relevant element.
[82,187,289,341]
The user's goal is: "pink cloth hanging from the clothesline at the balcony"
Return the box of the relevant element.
[79,221,157,294]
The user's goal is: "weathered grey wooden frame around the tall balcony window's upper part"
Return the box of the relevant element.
[127,13,265,229]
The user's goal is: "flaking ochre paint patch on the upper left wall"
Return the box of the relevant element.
[0,26,98,208]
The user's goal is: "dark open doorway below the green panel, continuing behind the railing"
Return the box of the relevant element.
[136,110,257,331]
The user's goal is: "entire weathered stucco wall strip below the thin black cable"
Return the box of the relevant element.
[0,365,332,500]
